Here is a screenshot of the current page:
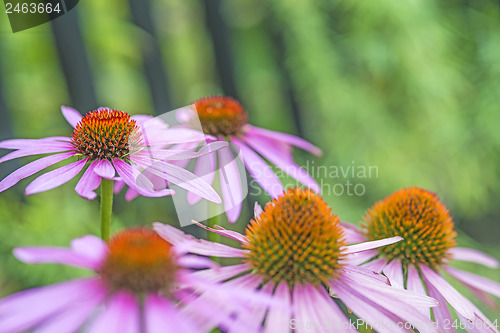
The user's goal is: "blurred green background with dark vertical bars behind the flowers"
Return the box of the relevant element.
[0,0,500,320]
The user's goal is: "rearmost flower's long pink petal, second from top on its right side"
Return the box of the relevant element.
[243,135,321,192]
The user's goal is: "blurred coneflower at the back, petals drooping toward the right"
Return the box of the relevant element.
[177,96,321,222]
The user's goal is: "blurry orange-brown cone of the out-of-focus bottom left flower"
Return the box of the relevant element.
[100,228,177,294]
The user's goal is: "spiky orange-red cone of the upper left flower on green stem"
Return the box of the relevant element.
[72,108,141,159]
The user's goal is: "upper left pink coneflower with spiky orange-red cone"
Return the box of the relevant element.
[0,106,222,203]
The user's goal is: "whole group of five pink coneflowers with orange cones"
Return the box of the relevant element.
[0,97,500,333]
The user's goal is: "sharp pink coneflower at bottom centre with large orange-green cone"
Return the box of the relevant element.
[153,188,438,333]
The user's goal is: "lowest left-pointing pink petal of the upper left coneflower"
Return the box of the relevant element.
[25,159,87,195]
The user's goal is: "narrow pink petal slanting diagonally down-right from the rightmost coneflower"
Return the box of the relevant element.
[420,265,474,320]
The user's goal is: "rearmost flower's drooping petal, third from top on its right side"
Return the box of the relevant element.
[231,138,284,199]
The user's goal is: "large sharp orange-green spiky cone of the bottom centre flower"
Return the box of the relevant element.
[243,188,346,285]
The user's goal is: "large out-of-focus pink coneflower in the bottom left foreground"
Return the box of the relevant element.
[0,228,266,333]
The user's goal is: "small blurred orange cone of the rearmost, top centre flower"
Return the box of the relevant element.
[194,96,248,137]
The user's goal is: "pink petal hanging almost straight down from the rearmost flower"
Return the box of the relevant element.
[218,148,243,223]
